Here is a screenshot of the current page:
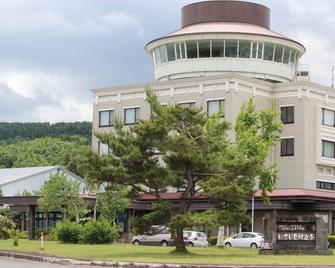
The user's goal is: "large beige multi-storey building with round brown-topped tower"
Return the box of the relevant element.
[92,1,335,232]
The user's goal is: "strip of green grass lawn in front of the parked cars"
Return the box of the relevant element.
[0,239,335,265]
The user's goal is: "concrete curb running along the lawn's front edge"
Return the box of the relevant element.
[0,250,335,268]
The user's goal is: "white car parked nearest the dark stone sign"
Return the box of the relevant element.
[223,232,264,248]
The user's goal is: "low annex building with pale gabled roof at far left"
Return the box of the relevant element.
[0,166,96,239]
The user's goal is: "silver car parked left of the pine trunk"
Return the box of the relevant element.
[132,226,173,247]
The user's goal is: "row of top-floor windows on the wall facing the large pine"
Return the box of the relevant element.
[99,99,224,127]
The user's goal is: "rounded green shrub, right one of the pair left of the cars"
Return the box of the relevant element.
[81,220,119,244]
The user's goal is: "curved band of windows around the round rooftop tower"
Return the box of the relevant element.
[153,39,299,66]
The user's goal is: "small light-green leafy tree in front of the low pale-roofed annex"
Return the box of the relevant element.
[38,174,86,221]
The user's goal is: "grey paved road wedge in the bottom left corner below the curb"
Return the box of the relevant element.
[0,257,88,268]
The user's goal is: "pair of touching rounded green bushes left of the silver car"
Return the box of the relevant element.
[55,220,119,244]
